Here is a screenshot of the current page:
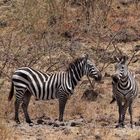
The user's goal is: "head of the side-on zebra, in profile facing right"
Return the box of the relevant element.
[85,55,102,81]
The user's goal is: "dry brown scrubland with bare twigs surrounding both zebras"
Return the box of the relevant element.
[0,0,140,140]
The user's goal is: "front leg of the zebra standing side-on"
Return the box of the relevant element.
[59,95,68,121]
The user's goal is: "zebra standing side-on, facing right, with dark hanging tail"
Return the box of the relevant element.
[8,55,102,124]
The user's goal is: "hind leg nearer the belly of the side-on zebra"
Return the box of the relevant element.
[22,91,32,123]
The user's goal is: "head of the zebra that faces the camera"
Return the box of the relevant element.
[112,56,128,83]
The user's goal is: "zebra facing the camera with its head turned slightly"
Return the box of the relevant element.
[110,56,138,128]
